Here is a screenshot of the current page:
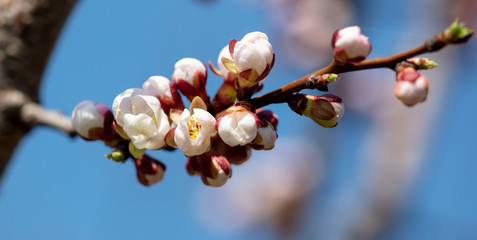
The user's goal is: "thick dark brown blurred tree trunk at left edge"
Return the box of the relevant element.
[0,0,76,178]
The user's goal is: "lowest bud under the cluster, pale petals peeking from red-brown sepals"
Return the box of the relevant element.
[199,155,232,187]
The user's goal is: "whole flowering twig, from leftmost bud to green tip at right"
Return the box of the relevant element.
[72,22,473,187]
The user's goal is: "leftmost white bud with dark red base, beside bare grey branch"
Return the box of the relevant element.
[71,101,114,140]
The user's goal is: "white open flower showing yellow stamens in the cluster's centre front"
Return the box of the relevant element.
[174,108,217,156]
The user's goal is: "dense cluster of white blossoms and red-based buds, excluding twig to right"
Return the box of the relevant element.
[73,32,278,187]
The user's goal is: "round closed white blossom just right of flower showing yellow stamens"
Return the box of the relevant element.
[217,105,260,147]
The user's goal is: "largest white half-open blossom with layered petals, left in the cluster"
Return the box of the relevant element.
[113,88,170,149]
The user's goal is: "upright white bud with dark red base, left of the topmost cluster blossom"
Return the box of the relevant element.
[172,58,209,101]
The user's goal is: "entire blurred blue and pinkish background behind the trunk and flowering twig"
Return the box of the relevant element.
[0,0,477,240]
